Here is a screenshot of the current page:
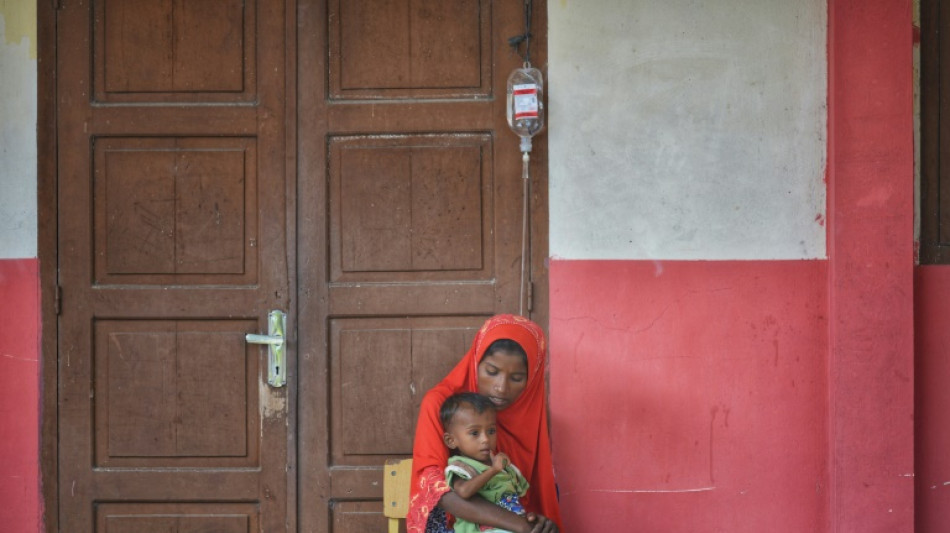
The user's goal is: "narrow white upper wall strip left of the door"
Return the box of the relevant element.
[0,0,37,259]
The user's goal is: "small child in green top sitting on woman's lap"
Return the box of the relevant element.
[439,392,528,533]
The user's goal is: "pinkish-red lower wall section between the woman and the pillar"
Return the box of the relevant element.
[550,261,828,533]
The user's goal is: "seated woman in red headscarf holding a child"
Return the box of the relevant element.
[406,315,561,533]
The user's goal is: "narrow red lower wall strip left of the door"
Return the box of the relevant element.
[0,259,42,531]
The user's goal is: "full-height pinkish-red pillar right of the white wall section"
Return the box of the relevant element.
[828,0,914,533]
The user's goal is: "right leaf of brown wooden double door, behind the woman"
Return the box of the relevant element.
[297,0,546,533]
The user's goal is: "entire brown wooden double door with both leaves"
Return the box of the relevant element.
[54,0,546,533]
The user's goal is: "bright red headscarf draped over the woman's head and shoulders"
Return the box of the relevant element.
[406,315,561,533]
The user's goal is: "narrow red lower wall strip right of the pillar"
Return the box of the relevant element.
[915,266,950,533]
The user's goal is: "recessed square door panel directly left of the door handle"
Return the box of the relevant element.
[93,320,260,467]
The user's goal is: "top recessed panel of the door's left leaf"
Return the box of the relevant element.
[92,0,256,103]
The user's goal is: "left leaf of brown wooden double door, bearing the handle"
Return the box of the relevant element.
[57,0,295,533]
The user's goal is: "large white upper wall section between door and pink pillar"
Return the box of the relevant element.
[546,0,827,260]
